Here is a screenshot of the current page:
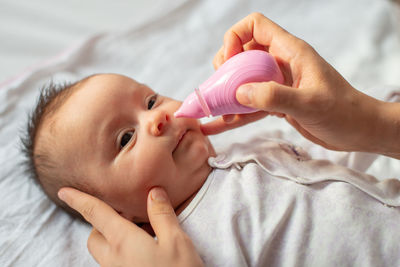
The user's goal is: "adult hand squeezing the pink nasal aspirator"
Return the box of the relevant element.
[202,13,400,157]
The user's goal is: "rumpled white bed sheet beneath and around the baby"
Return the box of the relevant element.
[0,0,400,266]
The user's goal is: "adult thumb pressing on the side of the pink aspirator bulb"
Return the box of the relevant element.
[236,81,301,114]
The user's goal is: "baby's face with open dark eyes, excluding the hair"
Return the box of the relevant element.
[52,74,215,222]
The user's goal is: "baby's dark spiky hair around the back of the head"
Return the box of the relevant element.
[21,76,94,219]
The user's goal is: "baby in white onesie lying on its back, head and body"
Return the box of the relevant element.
[24,74,400,266]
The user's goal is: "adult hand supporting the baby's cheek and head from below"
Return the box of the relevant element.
[59,188,203,266]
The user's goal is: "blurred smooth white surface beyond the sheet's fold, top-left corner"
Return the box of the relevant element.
[0,0,184,83]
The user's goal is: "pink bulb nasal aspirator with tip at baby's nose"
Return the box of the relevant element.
[174,50,283,118]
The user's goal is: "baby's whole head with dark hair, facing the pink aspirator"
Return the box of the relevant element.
[23,74,215,223]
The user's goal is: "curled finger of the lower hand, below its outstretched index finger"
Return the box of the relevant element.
[87,228,110,266]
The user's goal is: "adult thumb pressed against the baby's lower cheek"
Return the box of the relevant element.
[147,187,180,242]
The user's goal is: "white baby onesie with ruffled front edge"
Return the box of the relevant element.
[178,138,400,266]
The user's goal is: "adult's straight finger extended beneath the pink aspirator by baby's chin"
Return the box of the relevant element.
[200,111,269,135]
